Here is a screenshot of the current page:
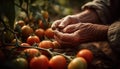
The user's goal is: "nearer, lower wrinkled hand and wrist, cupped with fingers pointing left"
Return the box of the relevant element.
[55,23,108,46]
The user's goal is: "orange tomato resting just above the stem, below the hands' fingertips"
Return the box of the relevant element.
[38,40,54,49]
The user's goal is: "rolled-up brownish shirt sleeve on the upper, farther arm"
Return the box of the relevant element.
[82,0,111,24]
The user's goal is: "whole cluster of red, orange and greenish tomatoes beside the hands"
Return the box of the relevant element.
[0,10,93,69]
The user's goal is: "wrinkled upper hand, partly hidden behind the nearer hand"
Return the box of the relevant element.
[51,15,80,30]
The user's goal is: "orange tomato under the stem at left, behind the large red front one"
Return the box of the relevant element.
[21,48,41,61]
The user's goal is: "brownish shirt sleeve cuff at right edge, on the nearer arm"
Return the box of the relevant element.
[108,21,120,54]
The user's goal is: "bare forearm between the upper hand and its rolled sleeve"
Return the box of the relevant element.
[75,9,100,23]
